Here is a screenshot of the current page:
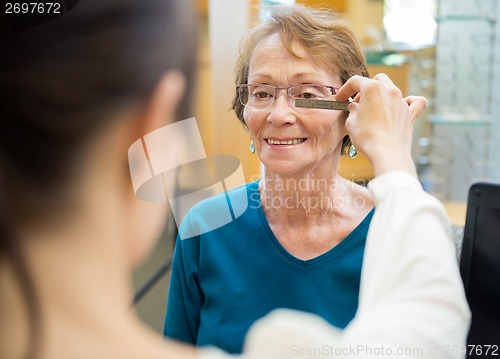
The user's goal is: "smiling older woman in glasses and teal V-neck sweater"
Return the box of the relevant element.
[165,6,373,353]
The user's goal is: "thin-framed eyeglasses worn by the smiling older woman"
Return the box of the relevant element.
[236,84,338,108]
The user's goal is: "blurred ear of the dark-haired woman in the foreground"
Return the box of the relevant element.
[133,70,186,141]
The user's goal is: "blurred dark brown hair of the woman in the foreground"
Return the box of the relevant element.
[0,0,197,356]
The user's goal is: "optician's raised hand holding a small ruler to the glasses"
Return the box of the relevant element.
[335,74,427,176]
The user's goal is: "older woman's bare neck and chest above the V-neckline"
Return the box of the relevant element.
[259,164,373,260]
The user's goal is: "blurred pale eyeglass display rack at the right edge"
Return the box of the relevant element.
[420,0,500,201]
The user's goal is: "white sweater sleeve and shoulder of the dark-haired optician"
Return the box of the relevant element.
[244,171,470,359]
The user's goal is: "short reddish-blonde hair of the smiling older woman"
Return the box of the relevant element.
[232,5,368,152]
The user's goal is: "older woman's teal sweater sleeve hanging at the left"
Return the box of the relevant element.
[163,231,203,344]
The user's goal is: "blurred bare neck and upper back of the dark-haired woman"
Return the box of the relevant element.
[0,217,195,359]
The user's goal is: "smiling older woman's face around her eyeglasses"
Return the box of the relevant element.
[243,34,346,175]
